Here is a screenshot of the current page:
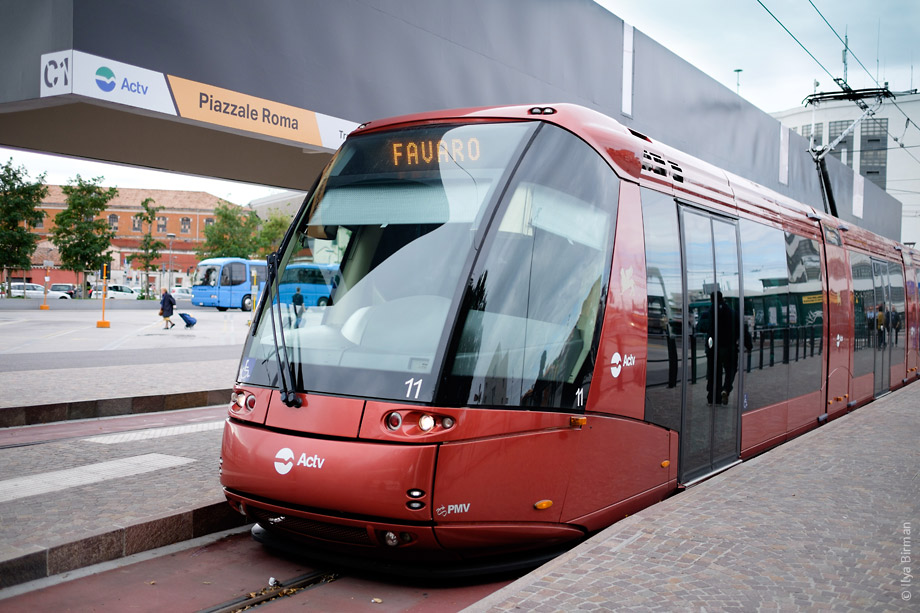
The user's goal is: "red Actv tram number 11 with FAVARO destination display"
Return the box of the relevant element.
[221,104,920,568]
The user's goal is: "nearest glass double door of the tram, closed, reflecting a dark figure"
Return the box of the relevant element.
[679,209,742,484]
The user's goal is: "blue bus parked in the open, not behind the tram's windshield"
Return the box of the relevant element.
[192,258,267,311]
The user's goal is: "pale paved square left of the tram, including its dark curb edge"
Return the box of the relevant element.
[0,300,251,427]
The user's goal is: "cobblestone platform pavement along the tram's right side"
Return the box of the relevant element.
[466,385,920,613]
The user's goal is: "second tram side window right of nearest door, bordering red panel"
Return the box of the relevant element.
[786,232,824,398]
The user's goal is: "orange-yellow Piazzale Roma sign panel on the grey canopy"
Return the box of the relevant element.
[167,75,323,146]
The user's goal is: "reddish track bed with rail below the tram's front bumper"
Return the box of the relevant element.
[0,520,517,613]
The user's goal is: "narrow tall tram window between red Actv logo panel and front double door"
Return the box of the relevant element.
[642,189,683,430]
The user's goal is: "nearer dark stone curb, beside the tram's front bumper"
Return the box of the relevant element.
[0,500,249,589]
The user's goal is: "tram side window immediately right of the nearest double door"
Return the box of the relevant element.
[739,219,789,411]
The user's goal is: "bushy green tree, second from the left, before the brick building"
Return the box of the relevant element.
[51,175,118,296]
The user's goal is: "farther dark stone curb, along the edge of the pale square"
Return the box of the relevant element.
[0,388,232,428]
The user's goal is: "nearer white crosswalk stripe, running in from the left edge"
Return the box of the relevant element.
[0,453,195,502]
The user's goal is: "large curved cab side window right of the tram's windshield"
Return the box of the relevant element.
[443,126,619,411]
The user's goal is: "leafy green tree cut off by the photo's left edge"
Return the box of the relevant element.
[0,158,48,296]
